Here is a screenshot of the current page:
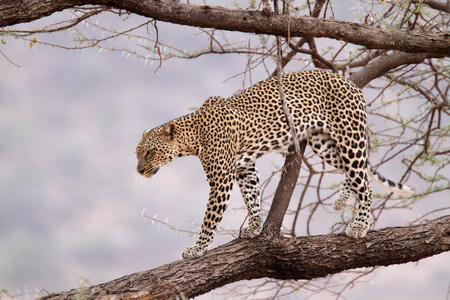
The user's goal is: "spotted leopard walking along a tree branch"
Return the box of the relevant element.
[136,69,414,259]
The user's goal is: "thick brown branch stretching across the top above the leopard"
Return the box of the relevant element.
[0,0,450,55]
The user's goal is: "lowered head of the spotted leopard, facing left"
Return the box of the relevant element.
[136,122,178,178]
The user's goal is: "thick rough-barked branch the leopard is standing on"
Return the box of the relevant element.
[43,216,450,300]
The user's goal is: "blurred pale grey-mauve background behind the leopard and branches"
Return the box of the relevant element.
[0,1,450,299]
